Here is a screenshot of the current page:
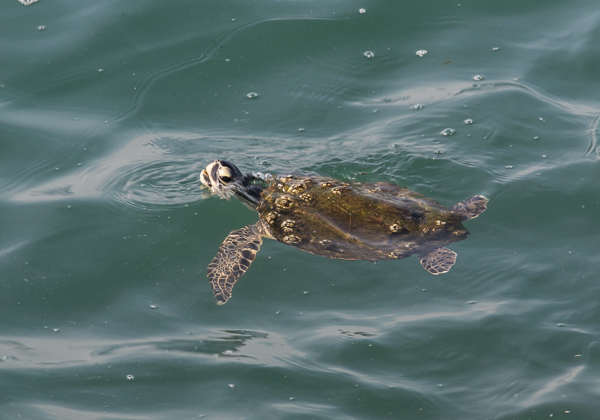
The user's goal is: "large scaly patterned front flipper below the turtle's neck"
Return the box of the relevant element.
[206,223,262,305]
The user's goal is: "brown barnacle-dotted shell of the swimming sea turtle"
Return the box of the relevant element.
[257,175,469,261]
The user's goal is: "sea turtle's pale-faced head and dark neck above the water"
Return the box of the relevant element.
[200,160,263,209]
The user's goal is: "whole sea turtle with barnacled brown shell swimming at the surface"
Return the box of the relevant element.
[200,160,488,305]
